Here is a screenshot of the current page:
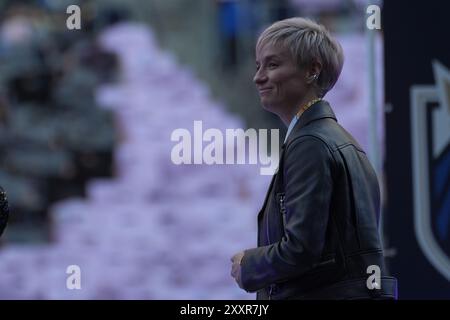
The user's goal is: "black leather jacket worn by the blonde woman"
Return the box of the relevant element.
[241,101,397,299]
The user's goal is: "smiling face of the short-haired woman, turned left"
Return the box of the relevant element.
[253,44,308,115]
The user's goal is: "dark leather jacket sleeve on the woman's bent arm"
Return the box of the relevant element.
[241,136,333,292]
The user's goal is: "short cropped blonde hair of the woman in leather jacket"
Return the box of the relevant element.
[256,17,344,97]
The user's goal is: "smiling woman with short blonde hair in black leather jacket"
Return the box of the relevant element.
[231,18,397,299]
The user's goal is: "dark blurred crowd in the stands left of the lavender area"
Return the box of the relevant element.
[0,1,118,240]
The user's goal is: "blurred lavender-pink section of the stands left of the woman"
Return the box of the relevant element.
[0,1,269,299]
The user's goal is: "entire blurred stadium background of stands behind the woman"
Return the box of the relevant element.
[0,0,449,299]
